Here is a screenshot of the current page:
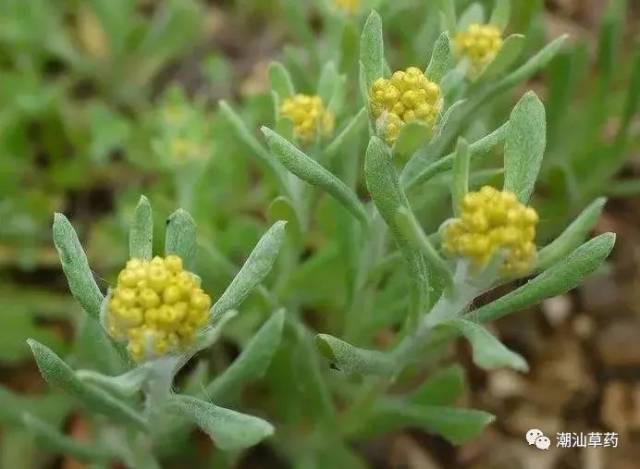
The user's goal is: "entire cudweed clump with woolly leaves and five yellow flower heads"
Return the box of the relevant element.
[24,1,615,468]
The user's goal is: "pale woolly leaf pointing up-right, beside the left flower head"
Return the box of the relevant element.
[210,221,286,321]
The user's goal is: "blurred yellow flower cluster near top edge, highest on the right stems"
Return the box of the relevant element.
[455,23,502,74]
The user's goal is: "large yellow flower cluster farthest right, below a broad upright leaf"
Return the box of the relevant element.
[443,186,538,276]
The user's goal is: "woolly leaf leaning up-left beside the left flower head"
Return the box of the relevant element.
[53,213,104,319]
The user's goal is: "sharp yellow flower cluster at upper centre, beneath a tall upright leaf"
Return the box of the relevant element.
[369,67,442,144]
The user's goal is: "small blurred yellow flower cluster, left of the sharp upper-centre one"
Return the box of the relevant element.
[280,94,335,143]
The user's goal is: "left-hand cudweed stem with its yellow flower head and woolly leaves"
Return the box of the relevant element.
[24,197,285,467]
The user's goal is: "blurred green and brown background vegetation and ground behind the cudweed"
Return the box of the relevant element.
[0,0,640,468]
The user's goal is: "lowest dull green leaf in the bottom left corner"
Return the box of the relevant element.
[22,413,116,462]
